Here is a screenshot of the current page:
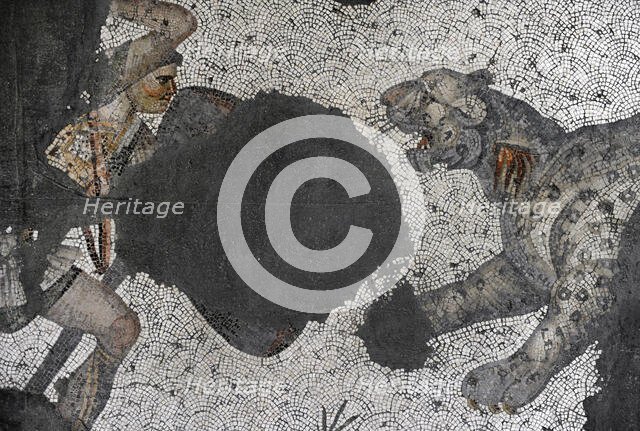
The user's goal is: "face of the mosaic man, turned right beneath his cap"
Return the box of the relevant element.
[127,64,178,114]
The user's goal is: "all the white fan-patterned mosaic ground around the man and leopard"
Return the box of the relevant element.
[5,0,640,430]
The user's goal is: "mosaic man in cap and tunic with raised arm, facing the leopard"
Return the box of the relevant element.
[0,0,197,430]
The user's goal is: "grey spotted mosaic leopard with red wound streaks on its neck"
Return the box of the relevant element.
[359,68,640,414]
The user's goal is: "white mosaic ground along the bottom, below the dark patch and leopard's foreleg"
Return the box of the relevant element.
[0,274,598,430]
